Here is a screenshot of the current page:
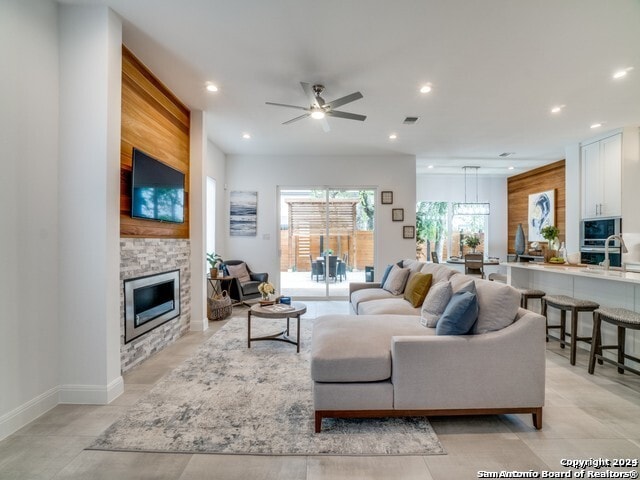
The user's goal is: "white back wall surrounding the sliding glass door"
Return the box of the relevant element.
[224,155,416,287]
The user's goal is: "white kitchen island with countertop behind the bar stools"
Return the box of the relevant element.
[503,262,640,373]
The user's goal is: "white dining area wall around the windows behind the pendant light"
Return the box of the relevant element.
[416,174,509,261]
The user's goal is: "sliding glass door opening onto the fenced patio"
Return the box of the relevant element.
[280,187,375,298]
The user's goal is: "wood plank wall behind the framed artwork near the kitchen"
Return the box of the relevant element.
[507,160,566,253]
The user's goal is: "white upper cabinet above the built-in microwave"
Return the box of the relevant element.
[580,133,622,218]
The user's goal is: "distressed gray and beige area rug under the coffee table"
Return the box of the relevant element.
[89,318,445,455]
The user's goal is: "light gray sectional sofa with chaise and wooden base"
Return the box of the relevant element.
[311,260,545,432]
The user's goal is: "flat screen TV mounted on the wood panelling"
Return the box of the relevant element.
[131,148,184,223]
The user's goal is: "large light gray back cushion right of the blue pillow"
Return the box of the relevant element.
[474,279,520,333]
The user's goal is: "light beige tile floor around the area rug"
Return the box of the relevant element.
[0,302,640,480]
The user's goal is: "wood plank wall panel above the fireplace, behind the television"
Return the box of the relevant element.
[120,45,191,238]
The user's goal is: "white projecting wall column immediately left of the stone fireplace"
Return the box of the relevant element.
[57,6,123,403]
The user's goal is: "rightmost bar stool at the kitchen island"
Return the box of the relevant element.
[589,307,640,375]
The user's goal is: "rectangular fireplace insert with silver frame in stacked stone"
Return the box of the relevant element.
[124,270,180,343]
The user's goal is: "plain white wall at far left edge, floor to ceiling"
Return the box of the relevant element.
[0,0,59,439]
